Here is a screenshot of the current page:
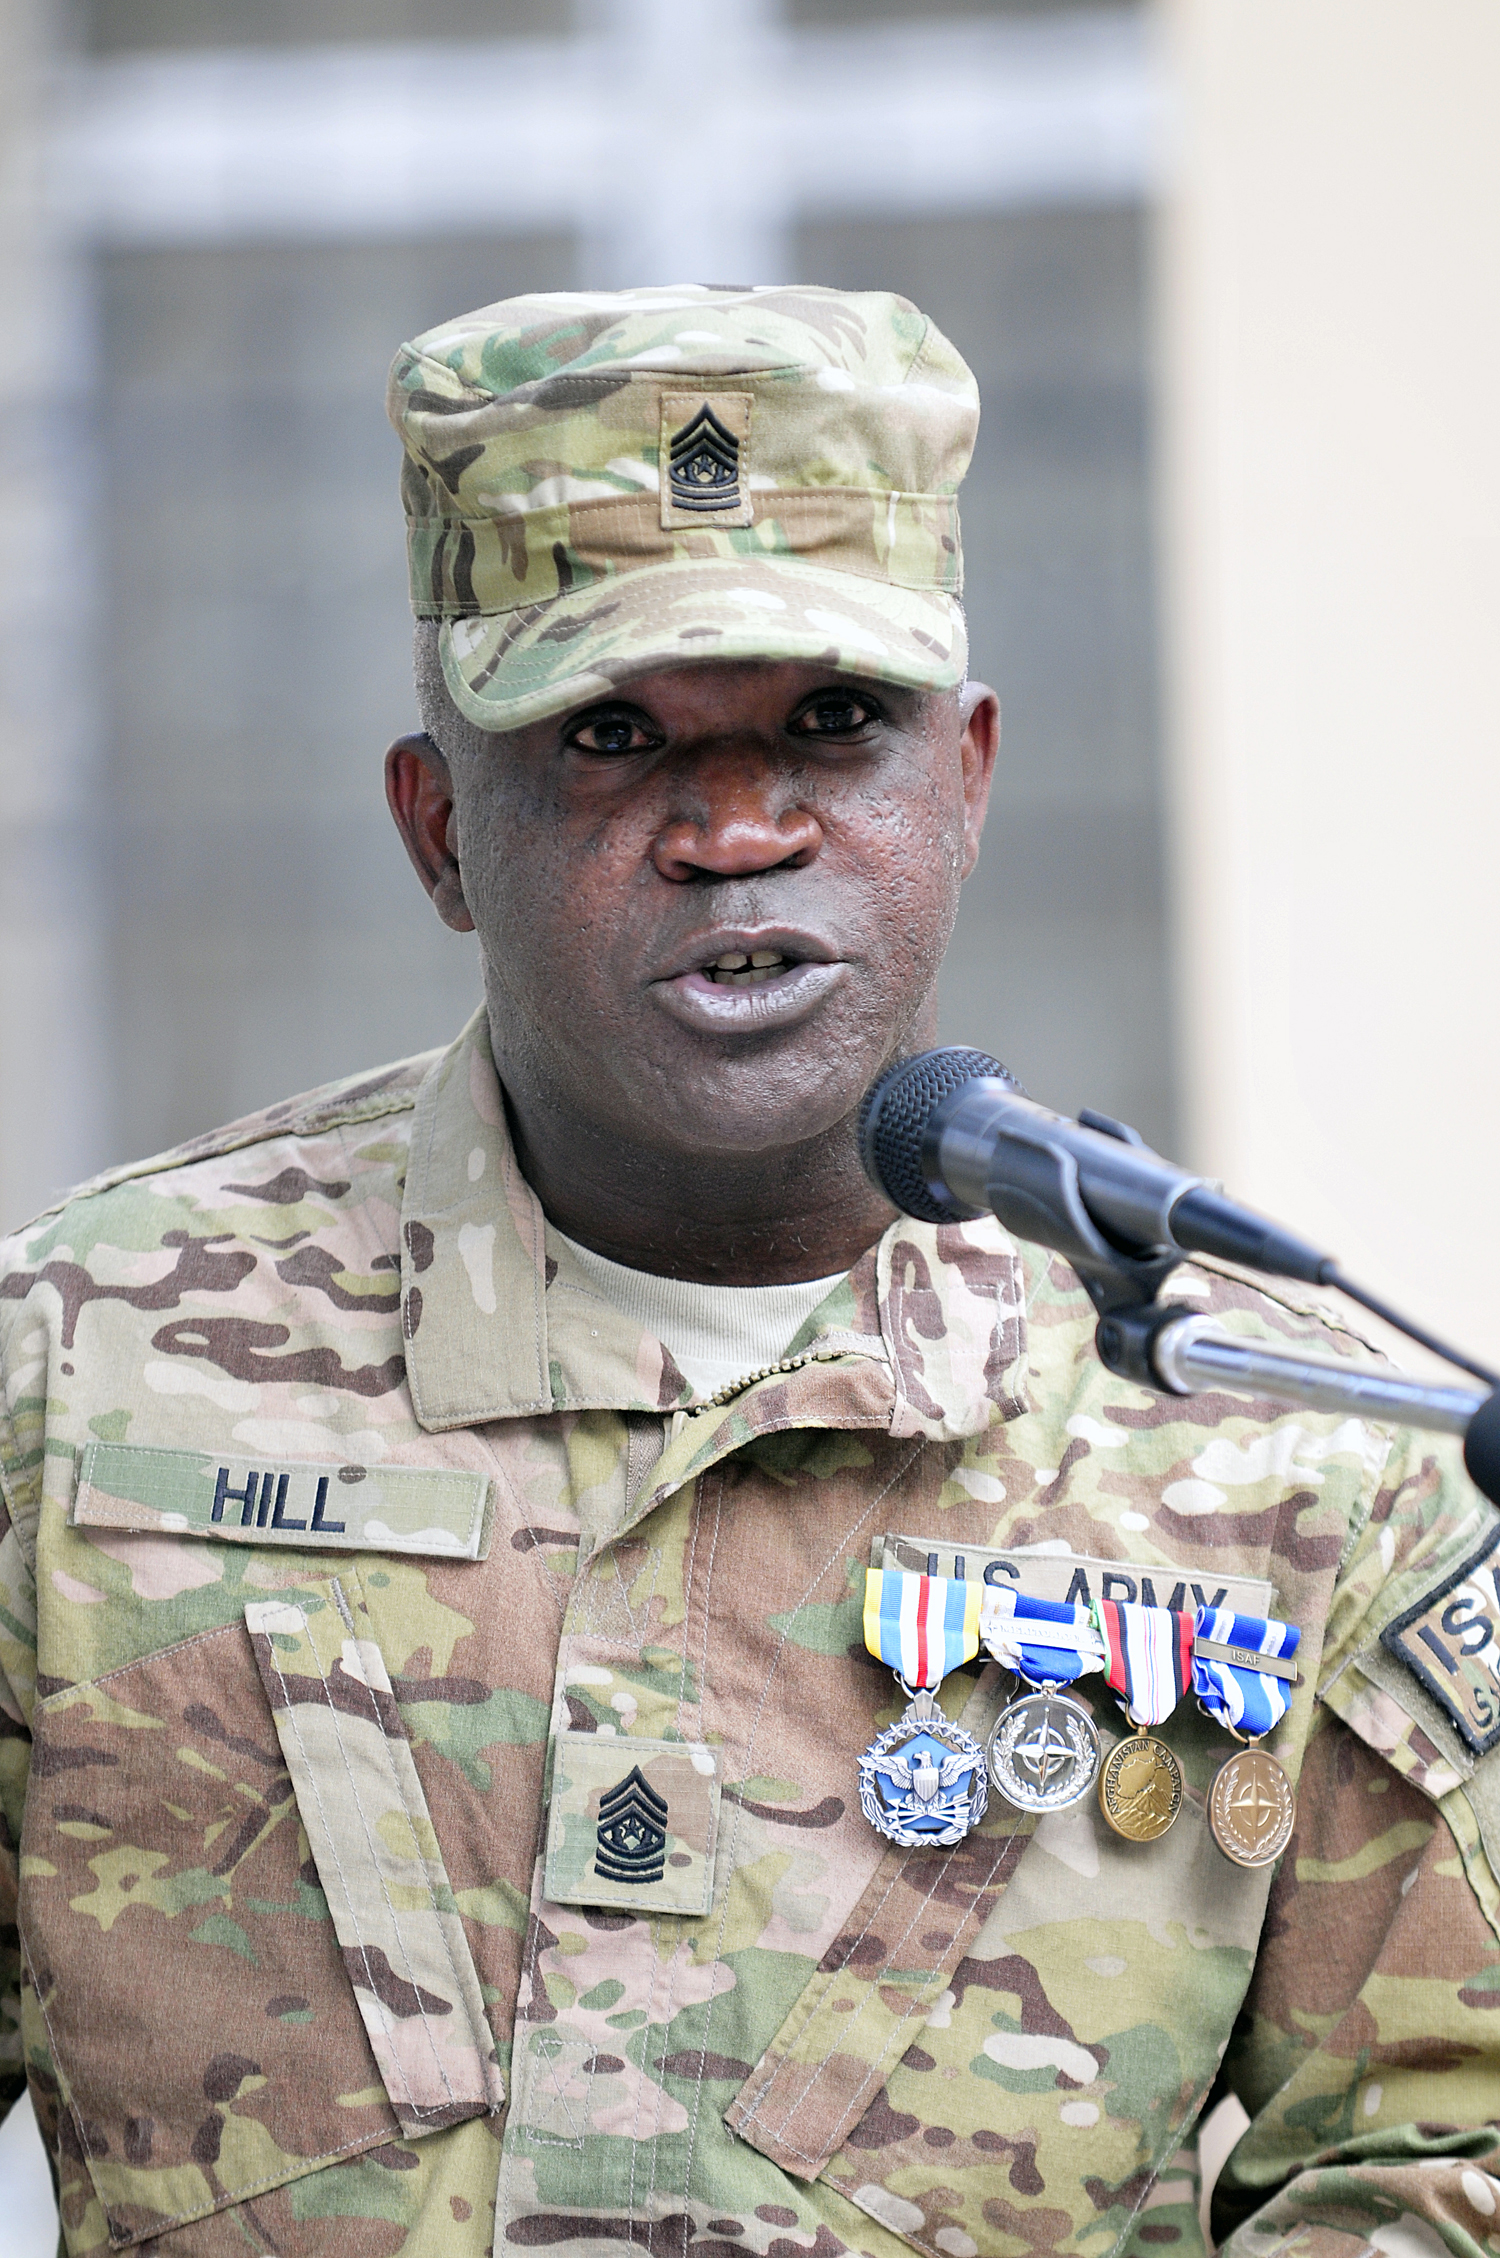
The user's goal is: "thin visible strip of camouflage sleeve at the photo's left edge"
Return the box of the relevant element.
[0,1336,41,2118]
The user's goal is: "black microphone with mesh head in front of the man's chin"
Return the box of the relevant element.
[858,1050,1342,1285]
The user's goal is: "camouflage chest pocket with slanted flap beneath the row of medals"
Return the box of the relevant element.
[725,1703,1272,2258]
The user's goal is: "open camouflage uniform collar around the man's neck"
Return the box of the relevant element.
[402,1007,1026,1456]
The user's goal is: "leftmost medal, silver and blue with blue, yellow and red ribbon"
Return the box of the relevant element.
[858,1567,989,1849]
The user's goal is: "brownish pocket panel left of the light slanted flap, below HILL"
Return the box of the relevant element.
[20,1621,415,2249]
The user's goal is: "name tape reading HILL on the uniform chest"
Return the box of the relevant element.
[70,1443,490,1560]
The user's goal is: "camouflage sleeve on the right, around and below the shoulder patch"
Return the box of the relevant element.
[1213,1438,1500,2258]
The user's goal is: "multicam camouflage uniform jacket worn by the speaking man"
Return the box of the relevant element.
[0,1021,1500,2258]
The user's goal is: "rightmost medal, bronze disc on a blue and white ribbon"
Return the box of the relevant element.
[1193,1608,1301,1867]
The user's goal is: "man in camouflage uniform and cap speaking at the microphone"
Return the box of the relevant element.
[0,289,1500,2258]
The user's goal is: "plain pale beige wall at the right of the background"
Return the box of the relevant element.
[1159,0,1500,1357]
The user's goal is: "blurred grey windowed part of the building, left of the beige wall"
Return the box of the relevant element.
[0,0,1172,1222]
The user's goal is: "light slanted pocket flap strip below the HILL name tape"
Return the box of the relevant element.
[244,1569,506,2134]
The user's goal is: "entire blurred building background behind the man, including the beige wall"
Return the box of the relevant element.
[0,0,1500,2249]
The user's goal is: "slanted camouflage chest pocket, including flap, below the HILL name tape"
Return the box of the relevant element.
[20,1569,504,2249]
